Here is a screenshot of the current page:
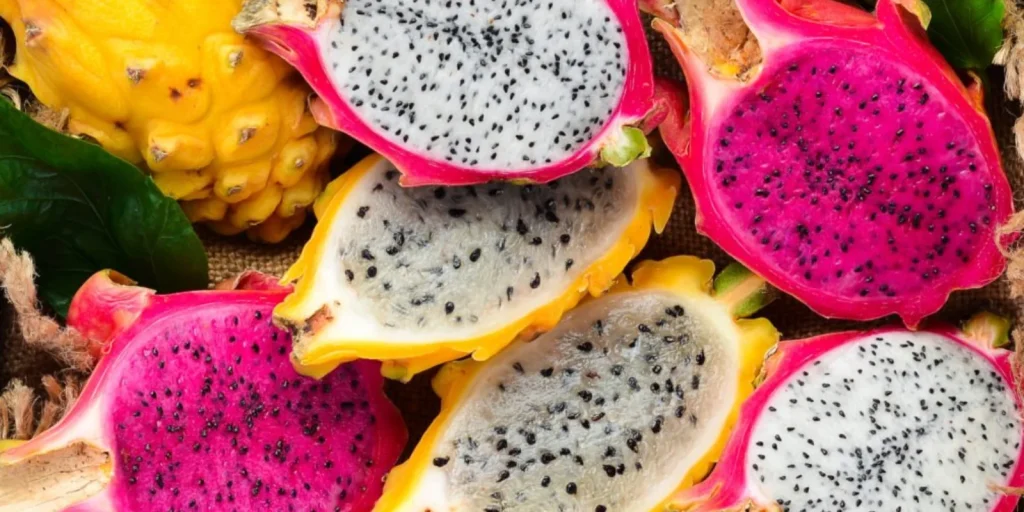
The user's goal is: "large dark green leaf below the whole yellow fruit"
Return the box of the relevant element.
[0,100,207,316]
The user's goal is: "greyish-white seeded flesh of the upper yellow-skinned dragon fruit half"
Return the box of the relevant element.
[324,163,639,333]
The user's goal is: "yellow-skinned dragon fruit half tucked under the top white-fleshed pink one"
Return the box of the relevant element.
[274,155,680,380]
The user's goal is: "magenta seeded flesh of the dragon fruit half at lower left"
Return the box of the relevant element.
[103,304,396,510]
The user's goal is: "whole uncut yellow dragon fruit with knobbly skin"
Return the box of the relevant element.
[0,0,338,243]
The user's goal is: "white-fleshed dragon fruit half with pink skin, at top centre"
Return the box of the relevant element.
[234,0,653,185]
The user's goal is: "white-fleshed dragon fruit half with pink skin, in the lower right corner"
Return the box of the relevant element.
[673,313,1024,512]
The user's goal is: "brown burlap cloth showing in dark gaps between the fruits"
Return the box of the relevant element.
[6,27,1024,460]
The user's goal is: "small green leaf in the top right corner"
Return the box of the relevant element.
[857,0,1006,71]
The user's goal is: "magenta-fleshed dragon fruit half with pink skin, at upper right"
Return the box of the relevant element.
[646,0,1013,327]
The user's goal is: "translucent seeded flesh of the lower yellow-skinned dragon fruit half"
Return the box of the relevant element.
[430,293,736,512]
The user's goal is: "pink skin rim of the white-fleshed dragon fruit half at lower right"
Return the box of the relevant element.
[673,326,1024,512]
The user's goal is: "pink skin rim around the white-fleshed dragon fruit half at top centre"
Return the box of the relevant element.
[240,0,654,186]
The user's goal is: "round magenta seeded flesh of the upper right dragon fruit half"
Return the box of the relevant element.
[708,43,999,299]
